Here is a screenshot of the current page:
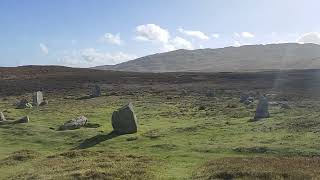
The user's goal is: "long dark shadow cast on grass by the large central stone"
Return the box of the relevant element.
[73,131,119,150]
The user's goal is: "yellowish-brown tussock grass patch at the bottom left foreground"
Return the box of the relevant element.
[6,150,153,180]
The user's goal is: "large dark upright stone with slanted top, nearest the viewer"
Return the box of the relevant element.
[112,103,138,134]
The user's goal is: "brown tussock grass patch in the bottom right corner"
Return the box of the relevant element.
[193,157,320,180]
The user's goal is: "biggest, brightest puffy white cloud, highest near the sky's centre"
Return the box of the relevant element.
[135,24,170,43]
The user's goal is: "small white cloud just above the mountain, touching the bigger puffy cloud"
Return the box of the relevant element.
[163,36,194,51]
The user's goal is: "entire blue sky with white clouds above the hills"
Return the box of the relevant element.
[0,0,320,67]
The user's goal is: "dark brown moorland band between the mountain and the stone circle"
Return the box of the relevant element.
[0,66,320,100]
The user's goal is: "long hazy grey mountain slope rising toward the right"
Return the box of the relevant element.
[95,43,320,72]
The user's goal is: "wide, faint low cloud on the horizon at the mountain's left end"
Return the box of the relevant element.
[58,48,137,67]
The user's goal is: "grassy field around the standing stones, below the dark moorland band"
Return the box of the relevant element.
[0,67,320,179]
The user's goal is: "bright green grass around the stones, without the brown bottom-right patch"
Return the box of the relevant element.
[0,94,320,179]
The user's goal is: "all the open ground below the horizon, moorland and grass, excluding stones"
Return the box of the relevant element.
[0,66,320,179]
